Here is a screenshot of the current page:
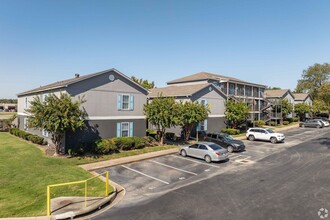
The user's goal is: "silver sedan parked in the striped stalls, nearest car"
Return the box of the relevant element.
[179,142,228,163]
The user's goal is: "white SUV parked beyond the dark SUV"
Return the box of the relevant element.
[246,128,285,144]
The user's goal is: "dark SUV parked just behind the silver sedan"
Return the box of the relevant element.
[204,133,245,152]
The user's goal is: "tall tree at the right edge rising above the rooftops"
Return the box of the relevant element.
[295,63,330,99]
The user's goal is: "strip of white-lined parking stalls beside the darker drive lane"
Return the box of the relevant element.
[97,128,328,204]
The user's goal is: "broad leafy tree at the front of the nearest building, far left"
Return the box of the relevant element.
[26,93,86,155]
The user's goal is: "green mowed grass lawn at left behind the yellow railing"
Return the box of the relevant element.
[0,132,111,217]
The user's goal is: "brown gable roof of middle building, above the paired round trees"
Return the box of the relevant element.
[148,83,226,98]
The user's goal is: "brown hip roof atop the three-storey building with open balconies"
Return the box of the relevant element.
[167,72,266,87]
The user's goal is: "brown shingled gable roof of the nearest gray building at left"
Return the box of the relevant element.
[17,68,148,96]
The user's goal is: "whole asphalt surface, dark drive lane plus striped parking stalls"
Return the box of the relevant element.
[93,128,330,220]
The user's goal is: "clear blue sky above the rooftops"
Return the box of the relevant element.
[0,0,330,98]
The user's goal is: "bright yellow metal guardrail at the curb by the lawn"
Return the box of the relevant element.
[47,171,109,216]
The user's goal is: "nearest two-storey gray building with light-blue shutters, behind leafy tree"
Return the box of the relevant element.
[17,69,148,151]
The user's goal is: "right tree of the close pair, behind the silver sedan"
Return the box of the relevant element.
[179,102,210,141]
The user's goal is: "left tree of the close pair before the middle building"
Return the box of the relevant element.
[143,96,180,144]
